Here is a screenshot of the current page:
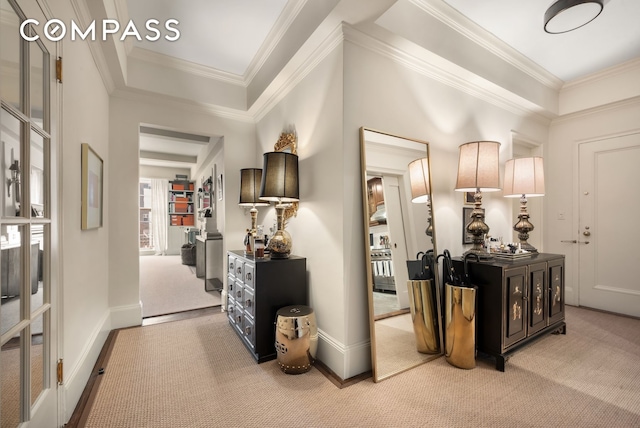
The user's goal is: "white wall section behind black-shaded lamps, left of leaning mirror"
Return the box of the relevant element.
[255,46,360,377]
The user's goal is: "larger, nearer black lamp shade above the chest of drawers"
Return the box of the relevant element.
[260,152,300,202]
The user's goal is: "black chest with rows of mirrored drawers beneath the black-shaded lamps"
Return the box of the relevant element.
[227,251,308,363]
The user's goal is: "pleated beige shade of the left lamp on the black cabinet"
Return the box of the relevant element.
[455,141,500,192]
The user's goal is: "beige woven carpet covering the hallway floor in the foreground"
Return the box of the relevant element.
[85,307,640,428]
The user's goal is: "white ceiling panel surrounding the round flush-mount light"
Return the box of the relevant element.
[444,0,640,82]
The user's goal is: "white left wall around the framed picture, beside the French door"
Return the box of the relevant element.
[53,2,115,420]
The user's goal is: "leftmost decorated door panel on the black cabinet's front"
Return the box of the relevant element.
[504,268,527,346]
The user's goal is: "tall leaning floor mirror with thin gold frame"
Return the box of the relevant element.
[360,127,444,382]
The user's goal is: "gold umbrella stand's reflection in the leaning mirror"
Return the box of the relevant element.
[407,279,440,354]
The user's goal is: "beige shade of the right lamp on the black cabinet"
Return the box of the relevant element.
[503,157,544,198]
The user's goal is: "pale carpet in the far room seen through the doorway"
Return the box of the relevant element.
[140,256,221,318]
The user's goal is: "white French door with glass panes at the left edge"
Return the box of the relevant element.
[0,0,61,428]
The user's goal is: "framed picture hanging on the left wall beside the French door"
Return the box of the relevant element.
[81,143,104,230]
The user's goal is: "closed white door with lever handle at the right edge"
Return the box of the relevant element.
[578,133,640,317]
